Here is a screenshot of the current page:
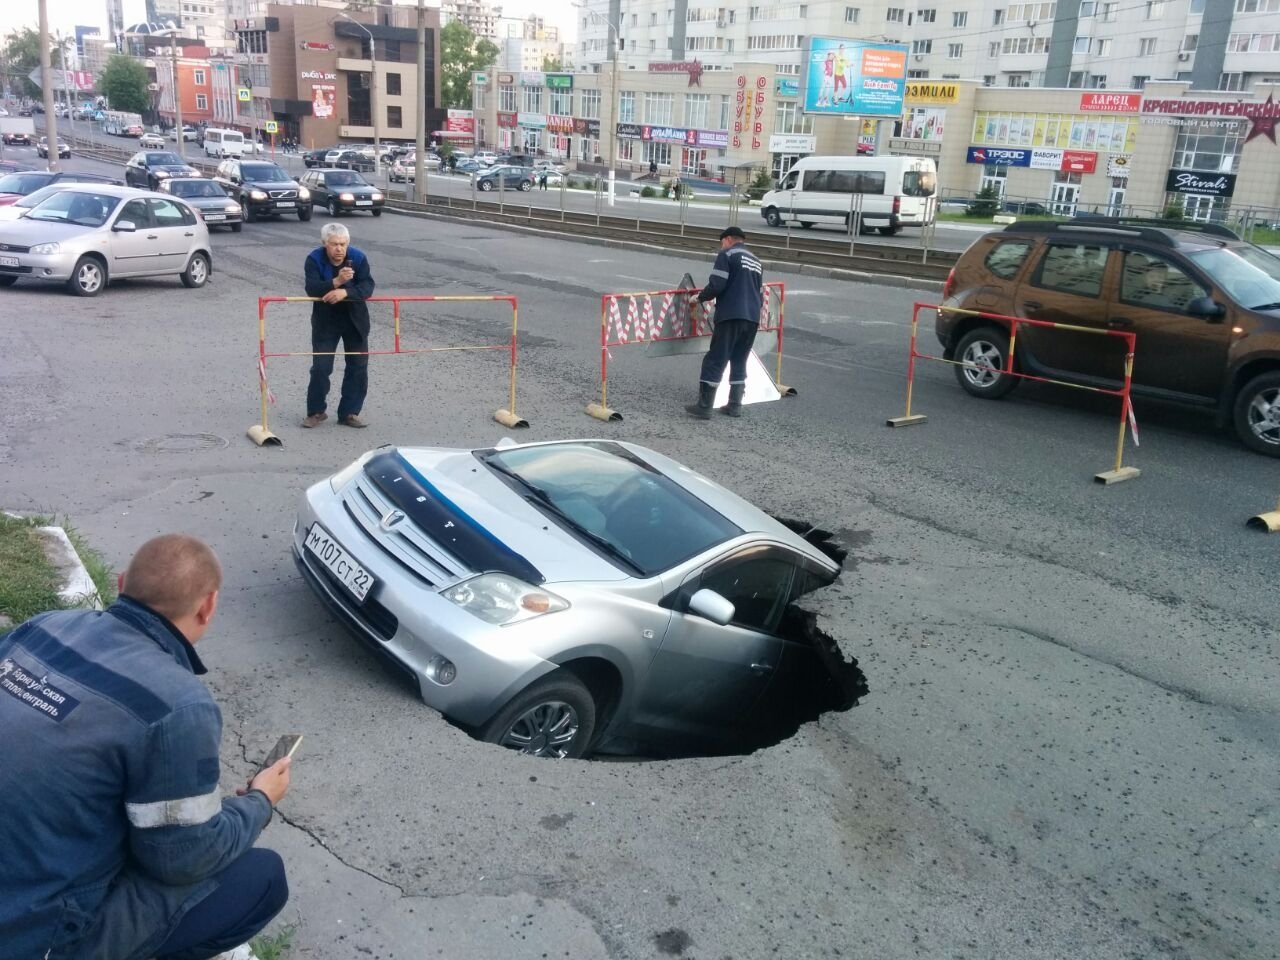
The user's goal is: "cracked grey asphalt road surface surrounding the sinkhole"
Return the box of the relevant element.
[0,184,1280,960]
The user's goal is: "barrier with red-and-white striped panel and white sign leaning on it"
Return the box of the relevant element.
[586,282,796,421]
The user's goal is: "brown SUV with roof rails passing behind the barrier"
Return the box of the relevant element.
[937,216,1280,457]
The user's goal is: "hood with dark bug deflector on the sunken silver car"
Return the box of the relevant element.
[365,447,630,584]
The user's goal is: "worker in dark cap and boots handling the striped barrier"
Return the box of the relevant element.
[685,227,764,420]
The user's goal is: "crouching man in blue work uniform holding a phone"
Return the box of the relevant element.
[0,534,289,960]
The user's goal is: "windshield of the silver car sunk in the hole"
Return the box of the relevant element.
[480,442,742,577]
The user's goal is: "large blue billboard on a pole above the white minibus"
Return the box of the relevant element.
[801,37,909,116]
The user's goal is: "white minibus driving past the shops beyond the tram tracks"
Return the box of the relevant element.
[760,156,938,237]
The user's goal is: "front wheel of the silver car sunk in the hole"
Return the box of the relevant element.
[480,671,595,759]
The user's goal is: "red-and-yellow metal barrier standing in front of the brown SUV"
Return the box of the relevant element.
[886,302,1142,484]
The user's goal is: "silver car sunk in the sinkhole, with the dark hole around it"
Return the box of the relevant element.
[293,440,865,756]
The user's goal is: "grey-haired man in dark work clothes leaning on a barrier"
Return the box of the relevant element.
[302,223,374,428]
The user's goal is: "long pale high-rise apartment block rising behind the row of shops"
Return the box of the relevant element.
[576,0,1280,92]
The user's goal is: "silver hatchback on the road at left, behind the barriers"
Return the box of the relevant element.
[0,184,212,297]
